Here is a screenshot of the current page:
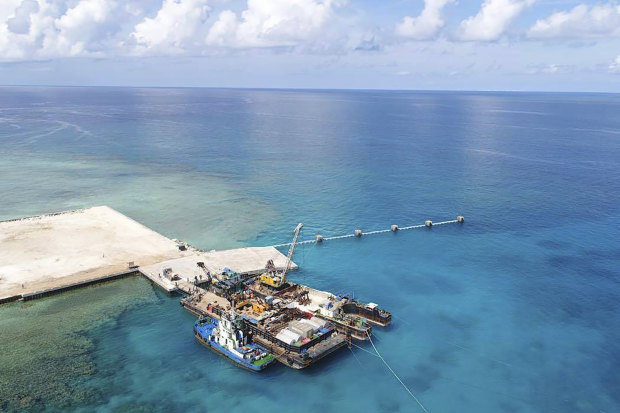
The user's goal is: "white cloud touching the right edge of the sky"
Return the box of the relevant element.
[528,4,620,39]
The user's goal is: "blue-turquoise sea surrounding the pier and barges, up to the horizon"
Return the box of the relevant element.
[0,88,620,412]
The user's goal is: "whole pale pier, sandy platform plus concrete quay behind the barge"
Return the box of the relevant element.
[0,206,297,304]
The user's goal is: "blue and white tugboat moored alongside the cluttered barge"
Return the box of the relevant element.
[194,310,276,371]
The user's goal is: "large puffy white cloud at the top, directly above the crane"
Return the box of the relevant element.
[206,0,341,48]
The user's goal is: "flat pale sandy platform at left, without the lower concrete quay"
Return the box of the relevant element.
[0,206,192,297]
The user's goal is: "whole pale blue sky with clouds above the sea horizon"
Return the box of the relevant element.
[0,0,620,92]
